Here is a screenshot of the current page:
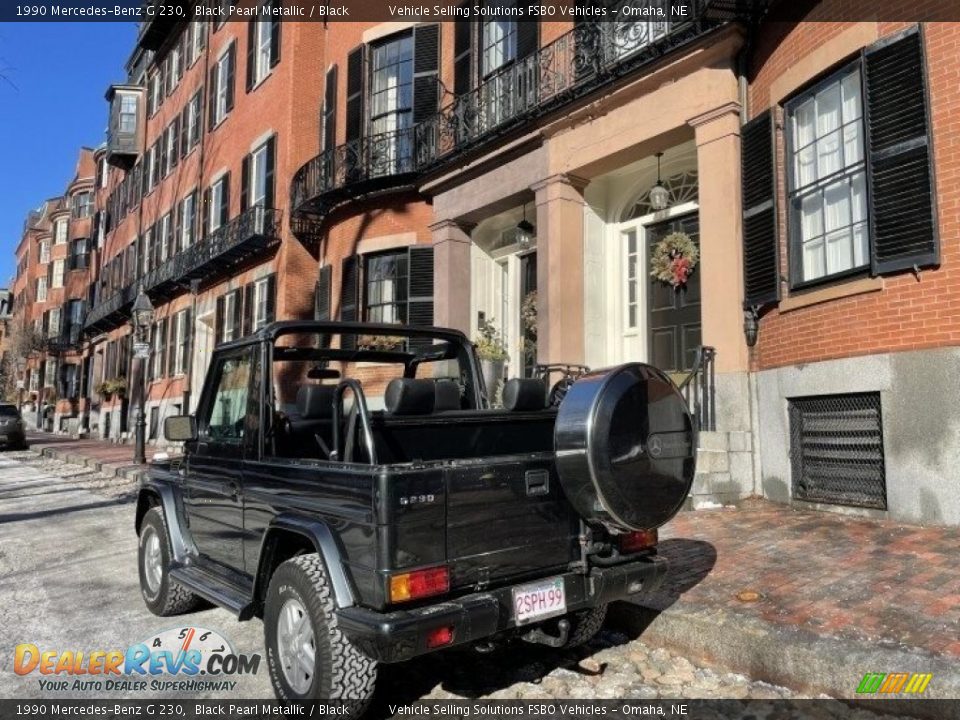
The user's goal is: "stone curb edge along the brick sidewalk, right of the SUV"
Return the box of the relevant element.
[609,601,960,720]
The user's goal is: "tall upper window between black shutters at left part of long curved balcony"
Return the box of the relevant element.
[370,33,413,141]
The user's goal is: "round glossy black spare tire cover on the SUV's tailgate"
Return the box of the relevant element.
[554,363,696,530]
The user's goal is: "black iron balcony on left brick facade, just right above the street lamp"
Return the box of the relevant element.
[142,206,280,296]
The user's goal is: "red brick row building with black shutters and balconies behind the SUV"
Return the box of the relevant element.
[11,2,960,524]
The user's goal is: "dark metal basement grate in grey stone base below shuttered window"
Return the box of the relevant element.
[788,393,887,510]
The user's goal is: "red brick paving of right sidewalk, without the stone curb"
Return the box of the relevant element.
[644,500,960,658]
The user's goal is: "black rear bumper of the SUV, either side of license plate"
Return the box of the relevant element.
[337,557,667,663]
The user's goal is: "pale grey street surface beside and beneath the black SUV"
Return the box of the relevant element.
[0,451,876,717]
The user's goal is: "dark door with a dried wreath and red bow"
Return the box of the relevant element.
[645,212,701,372]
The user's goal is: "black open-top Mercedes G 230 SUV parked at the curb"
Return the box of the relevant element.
[136,322,696,714]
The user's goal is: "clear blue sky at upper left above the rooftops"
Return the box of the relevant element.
[0,22,137,287]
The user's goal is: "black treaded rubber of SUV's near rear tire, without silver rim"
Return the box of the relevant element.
[263,553,377,717]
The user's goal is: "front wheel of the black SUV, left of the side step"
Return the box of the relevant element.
[137,506,200,617]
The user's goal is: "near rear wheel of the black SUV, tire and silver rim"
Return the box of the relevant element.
[263,553,377,717]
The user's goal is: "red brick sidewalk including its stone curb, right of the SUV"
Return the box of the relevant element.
[614,500,960,704]
